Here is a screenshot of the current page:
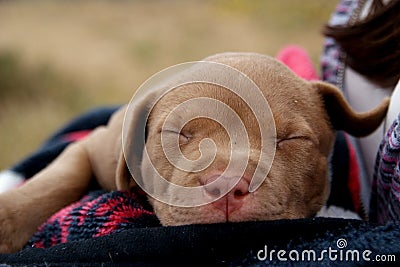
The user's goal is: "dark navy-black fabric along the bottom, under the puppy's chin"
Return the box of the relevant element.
[0,218,400,266]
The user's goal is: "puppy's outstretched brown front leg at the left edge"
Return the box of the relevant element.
[0,142,92,253]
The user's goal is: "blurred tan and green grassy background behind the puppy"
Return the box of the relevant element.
[0,0,338,170]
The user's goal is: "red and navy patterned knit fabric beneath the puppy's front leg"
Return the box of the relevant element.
[27,191,160,248]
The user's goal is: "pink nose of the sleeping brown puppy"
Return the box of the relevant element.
[204,175,249,218]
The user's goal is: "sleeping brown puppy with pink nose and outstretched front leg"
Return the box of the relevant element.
[0,53,389,253]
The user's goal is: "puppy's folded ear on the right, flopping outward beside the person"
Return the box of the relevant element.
[311,82,390,137]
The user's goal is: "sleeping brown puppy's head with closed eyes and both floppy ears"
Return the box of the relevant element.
[117,53,388,225]
